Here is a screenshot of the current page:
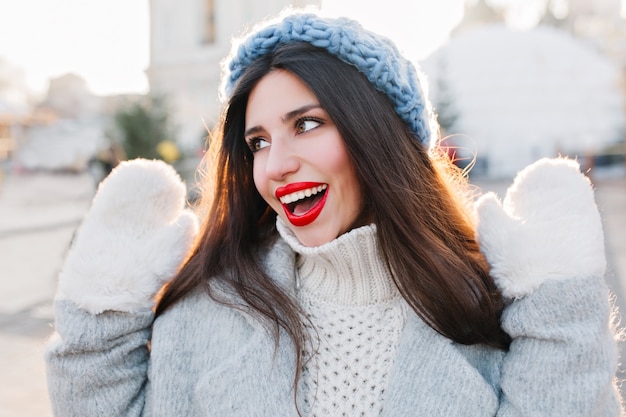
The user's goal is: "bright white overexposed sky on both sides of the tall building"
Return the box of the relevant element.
[0,0,626,95]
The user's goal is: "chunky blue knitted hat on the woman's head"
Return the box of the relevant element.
[222,13,435,148]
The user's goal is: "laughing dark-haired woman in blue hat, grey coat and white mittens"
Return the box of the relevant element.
[47,10,620,416]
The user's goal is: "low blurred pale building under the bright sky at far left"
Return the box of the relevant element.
[12,74,142,172]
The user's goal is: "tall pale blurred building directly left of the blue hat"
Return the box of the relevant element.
[147,0,321,151]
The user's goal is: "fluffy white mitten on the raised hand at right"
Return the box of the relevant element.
[476,158,606,298]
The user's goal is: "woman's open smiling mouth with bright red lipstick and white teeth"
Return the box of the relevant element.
[276,183,328,226]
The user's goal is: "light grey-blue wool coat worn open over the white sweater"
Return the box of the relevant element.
[47,236,620,417]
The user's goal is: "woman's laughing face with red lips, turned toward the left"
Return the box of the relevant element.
[245,70,362,246]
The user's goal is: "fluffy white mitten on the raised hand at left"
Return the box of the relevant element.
[57,159,198,314]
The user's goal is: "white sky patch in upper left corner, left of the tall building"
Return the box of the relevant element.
[0,0,149,94]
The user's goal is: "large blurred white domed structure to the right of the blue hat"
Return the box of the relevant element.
[422,0,626,177]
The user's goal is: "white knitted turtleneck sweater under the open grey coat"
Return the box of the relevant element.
[277,220,408,416]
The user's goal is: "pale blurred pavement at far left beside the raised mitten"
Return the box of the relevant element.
[0,174,93,417]
